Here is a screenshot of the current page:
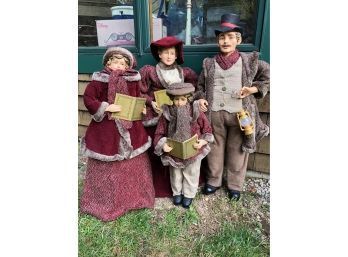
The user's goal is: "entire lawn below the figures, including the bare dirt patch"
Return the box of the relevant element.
[78,153,270,257]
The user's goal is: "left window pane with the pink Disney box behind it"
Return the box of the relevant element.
[78,0,135,46]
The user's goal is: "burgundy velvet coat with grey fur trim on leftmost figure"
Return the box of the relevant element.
[81,73,151,161]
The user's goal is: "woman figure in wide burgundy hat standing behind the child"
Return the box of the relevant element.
[139,36,203,197]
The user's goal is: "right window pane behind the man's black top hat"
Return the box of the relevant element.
[150,0,257,45]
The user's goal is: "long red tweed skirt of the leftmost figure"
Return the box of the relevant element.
[80,153,155,221]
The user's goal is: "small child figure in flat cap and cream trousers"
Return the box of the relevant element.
[154,83,214,208]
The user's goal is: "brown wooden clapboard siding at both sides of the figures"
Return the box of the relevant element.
[78,74,270,174]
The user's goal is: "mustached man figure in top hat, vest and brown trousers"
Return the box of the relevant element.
[197,13,270,201]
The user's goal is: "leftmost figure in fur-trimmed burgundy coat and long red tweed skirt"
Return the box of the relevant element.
[80,47,155,221]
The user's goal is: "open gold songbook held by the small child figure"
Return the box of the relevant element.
[167,134,198,160]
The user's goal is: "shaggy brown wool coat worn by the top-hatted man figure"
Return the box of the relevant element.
[197,52,270,153]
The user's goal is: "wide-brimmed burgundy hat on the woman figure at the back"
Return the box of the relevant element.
[150,37,184,64]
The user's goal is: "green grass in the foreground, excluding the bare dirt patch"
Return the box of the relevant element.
[79,200,269,257]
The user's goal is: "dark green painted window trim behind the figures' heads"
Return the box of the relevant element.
[78,0,270,73]
